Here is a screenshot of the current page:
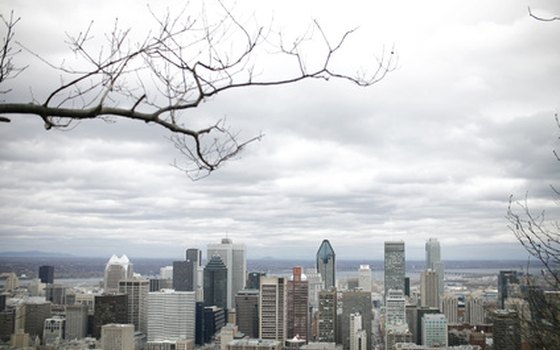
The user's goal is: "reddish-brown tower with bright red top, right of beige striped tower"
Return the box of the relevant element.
[287,266,309,341]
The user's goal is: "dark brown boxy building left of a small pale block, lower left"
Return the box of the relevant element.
[21,299,52,339]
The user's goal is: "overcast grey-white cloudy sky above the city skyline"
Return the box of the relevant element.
[0,0,560,259]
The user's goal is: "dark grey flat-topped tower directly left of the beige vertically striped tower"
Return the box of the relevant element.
[235,289,259,338]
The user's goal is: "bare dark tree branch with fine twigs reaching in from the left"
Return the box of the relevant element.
[0,1,397,177]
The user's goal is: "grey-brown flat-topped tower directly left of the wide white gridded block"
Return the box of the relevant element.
[119,279,150,334]
